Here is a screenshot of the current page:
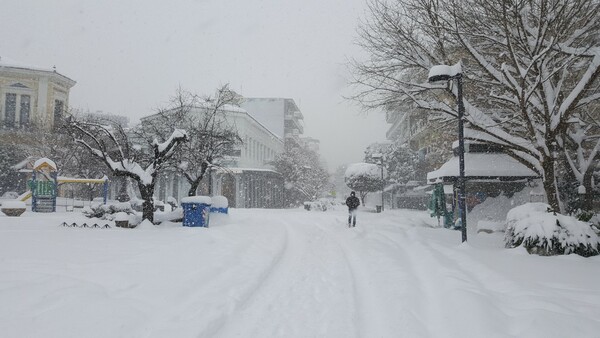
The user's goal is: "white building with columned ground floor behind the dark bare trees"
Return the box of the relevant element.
[142,106,284,208]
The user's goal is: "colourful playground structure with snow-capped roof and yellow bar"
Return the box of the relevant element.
[19,158,109,212]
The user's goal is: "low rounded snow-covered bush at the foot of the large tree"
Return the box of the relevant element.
[504,203,600,257]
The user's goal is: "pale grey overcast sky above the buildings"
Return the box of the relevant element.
[0,0,387,169]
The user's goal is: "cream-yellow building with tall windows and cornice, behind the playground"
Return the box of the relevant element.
[0,56,75,129]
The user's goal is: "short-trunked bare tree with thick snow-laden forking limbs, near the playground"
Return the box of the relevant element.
[65,118,187,222]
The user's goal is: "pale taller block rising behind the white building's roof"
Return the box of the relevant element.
[240,98,304,148]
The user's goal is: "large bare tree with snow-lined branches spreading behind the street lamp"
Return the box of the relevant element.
[354,0,600,210]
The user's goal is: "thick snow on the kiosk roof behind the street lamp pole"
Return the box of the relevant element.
[427,153,539,183]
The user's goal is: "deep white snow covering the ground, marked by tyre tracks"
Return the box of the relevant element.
[0,209,600,338]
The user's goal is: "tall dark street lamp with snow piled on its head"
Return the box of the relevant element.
[428,61,467,242]
